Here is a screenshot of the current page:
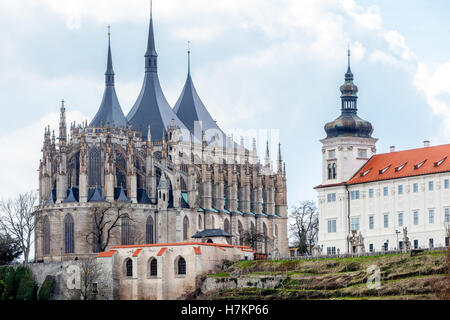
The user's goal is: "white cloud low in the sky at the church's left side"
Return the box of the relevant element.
[0,111,87,198]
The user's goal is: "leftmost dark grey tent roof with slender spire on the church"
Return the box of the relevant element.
[89,34,127,127]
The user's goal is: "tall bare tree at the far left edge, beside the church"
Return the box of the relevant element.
[0,191,38,265]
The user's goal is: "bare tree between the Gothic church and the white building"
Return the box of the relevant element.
[289,200,319,254]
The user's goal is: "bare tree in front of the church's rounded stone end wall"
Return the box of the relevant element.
[86,203,137,252]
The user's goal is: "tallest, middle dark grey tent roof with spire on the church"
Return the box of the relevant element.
[127,7,187,140]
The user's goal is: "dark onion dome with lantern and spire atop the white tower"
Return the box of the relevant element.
[325,50,373,138]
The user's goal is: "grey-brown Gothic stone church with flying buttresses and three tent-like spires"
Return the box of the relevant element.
[35,6,288,262]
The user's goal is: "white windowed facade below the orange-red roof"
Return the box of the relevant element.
[318,154,450,253]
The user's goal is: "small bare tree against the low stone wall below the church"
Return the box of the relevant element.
[80,257,102,300]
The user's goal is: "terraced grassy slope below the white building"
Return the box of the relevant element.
[206,251,449,300]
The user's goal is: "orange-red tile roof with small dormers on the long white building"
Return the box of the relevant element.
[347,144,450,185]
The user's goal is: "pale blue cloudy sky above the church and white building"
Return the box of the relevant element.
[0,0,450,207]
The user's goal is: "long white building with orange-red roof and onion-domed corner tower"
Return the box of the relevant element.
[316,52,450,254]
